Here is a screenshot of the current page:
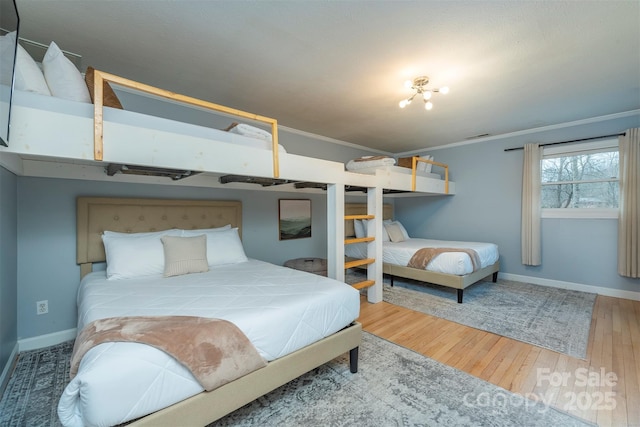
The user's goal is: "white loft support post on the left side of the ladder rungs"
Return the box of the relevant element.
[327,184,344,282]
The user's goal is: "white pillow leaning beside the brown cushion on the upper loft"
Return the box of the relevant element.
[42,42,91,103]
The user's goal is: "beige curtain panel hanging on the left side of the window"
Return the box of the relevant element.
[521,144,542,265]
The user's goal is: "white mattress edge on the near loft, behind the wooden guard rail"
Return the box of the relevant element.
[12,90,286,153]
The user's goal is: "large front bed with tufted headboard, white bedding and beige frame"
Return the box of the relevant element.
[58,197,362,426]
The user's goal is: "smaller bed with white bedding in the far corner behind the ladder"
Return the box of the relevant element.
[345,203,500,303]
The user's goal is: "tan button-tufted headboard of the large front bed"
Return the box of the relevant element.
[76,197,242,277]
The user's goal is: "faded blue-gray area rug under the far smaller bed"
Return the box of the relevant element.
[350,272,596,359]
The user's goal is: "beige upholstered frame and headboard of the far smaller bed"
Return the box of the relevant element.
[345,203,500,304]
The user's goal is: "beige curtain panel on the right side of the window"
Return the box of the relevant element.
[618,128,640,278]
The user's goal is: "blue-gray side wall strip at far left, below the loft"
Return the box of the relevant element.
[0,167,18,382]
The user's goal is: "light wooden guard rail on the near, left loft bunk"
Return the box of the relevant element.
[93,70,280,178]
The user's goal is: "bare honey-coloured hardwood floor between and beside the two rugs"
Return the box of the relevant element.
[359,295,640,426]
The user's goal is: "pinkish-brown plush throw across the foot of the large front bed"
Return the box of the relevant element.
[70,316,267,391]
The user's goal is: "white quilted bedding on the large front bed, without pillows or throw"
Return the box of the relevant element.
[58,260,360,426]
